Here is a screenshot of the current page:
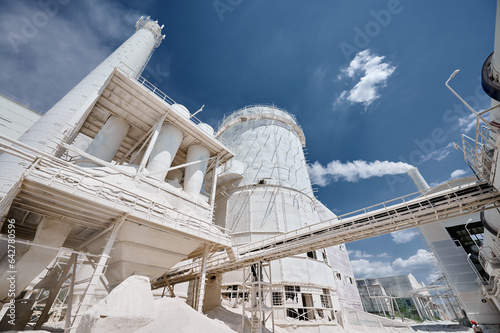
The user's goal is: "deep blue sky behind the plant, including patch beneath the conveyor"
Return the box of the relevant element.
[0,0,495,282]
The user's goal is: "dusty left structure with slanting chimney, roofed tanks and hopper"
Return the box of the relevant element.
[0,17,233,331]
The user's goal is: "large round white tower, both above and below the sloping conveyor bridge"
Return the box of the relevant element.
[215,105,339,329]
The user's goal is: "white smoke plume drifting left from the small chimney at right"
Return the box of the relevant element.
[308,160,412,186]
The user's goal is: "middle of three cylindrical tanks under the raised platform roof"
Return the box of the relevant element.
[146,124,184,180]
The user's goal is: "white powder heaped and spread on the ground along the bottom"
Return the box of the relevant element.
[4,276,500,333]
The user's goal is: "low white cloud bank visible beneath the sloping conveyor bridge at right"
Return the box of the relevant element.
[351,249,434,281]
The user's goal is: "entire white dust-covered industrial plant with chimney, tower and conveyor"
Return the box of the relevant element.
[0,2,500,333]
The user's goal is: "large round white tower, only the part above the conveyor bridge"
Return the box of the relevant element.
[215,106,320,244]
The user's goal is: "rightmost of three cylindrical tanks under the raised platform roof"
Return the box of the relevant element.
[184,144,210,196]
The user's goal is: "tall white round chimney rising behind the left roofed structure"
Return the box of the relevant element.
[0,17,162,197]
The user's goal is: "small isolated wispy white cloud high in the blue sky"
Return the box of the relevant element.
[334,50,396,108]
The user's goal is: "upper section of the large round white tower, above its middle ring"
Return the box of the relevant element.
[217,106,312,195]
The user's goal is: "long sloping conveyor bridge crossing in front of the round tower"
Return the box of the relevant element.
[152,176,500,289]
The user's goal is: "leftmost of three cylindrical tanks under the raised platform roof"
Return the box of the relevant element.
[80,116,130,166]
